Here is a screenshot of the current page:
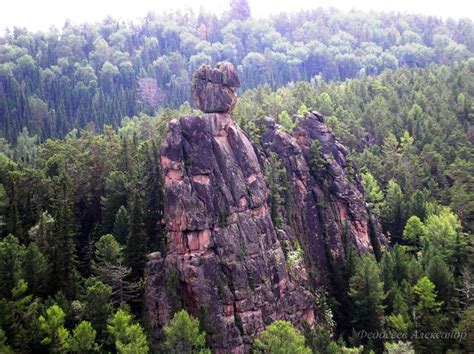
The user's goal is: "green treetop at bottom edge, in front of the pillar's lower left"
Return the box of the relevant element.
[163,310,210,353]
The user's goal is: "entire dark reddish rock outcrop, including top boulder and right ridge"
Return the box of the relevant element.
[145,64,382,353]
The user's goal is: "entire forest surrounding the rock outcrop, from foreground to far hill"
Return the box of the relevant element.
[0,1,474,353]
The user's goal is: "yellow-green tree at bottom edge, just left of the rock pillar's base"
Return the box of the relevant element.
[107,309,149,354]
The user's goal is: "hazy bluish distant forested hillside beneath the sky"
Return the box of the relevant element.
[0,5,474,142]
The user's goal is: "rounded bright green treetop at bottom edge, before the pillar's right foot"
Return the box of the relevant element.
[253,320,311,354]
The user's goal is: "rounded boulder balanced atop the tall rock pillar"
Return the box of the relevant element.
[192,62,240,113]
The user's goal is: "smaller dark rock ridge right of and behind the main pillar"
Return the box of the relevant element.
[261,112,383,285]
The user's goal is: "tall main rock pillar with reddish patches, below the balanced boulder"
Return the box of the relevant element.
[145,113,314,353]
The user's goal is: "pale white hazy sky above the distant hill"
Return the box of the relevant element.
[0,0,474,31]
